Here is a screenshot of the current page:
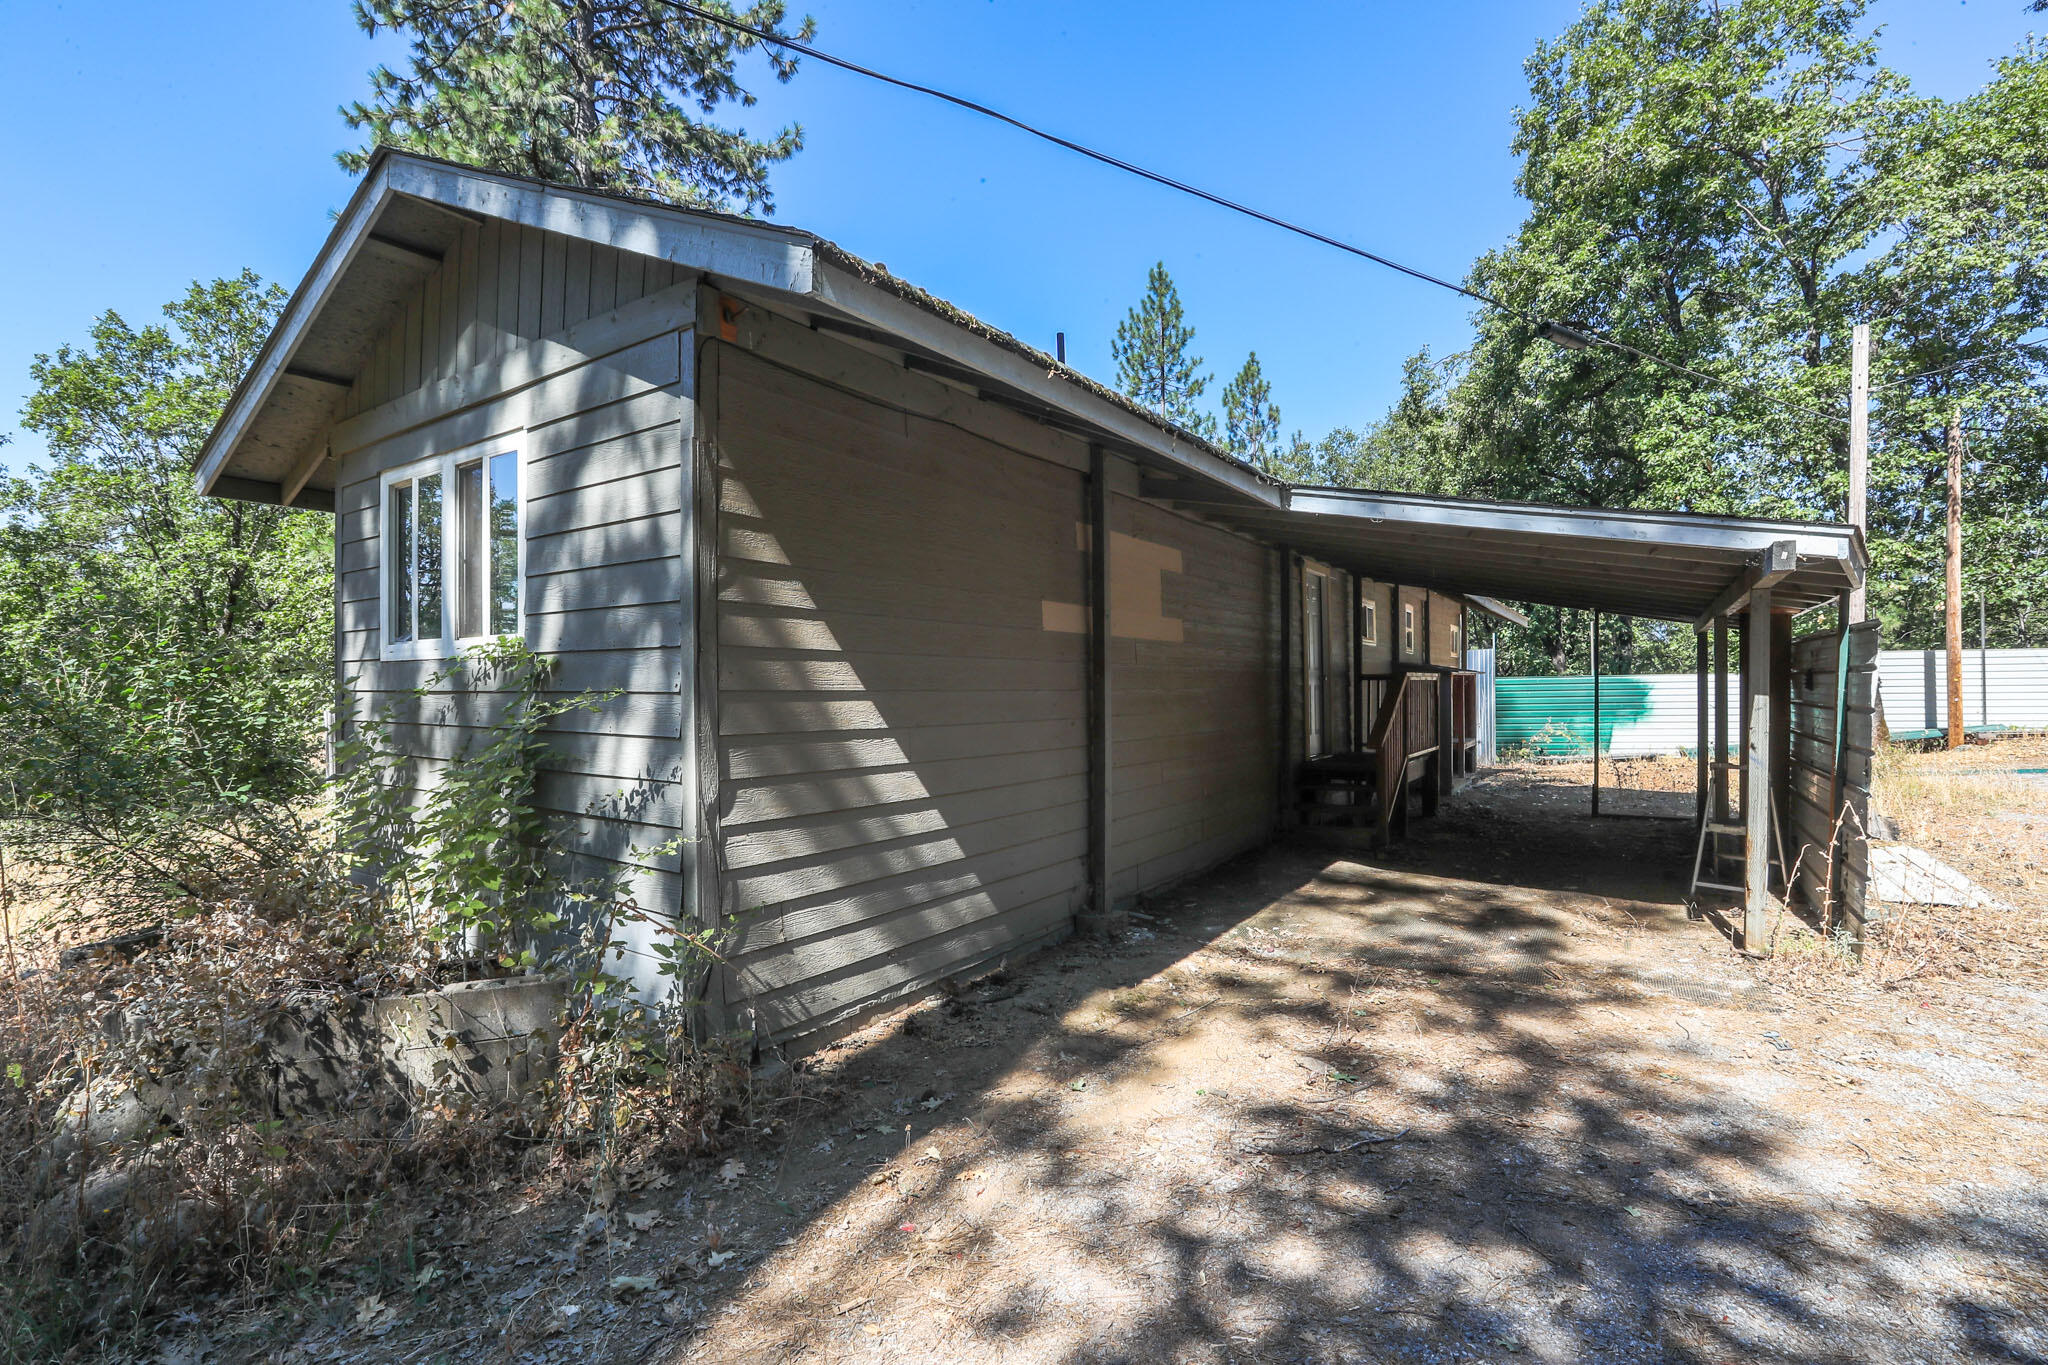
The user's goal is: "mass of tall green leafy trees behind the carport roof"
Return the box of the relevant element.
[1343,0,2048,667]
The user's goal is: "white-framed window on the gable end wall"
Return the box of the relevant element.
[377,432,526,659]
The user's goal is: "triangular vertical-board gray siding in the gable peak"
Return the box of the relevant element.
[340,219,678,417]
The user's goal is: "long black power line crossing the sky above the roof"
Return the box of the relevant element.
[664,0,1847,422]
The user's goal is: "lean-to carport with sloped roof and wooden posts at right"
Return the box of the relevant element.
[1147,483,1876,952]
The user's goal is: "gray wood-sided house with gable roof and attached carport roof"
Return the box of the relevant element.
[197,151,1864,1040]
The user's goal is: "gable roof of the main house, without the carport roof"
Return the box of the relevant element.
[197,149,1284,508]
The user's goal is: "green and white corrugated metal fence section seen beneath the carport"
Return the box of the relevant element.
[1493,673,1741,757]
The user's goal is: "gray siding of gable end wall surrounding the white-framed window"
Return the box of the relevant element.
[336,258,694,995]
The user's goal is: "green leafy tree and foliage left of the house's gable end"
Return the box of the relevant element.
[0,272,334,909]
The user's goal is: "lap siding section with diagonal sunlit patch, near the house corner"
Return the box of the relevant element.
[717,350,1087,1038]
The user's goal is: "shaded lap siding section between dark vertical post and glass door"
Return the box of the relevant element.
[1110,497,1280,898]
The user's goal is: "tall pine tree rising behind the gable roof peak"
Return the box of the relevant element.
[340,0,817,213]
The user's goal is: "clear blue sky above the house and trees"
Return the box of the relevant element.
[0,0,2040,474]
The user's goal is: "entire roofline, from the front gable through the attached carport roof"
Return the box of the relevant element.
[197,149,1866,620]
